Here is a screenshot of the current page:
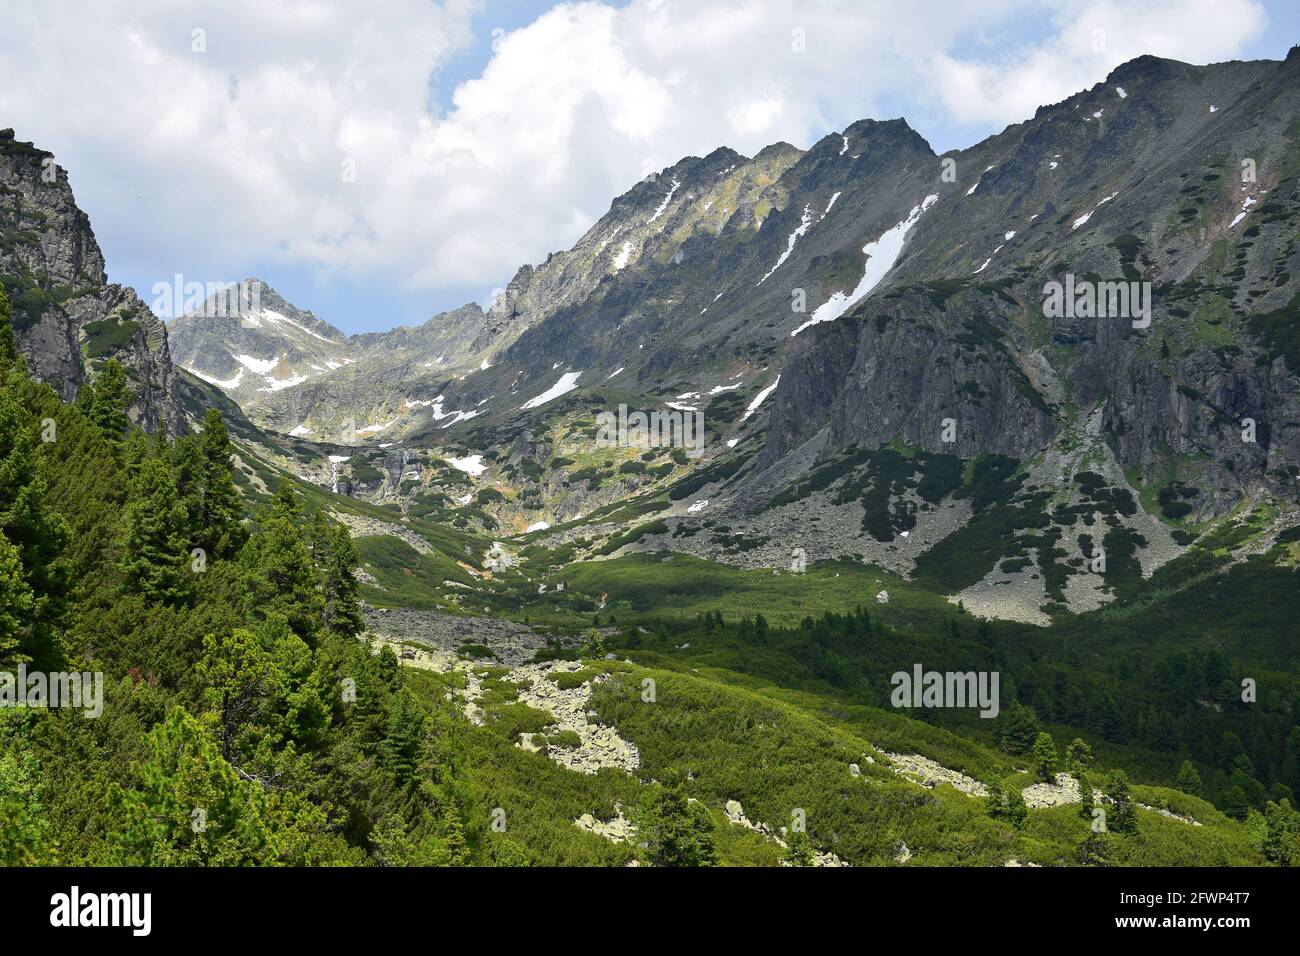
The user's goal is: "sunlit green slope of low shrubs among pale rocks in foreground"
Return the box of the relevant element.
[420,662,1261,865]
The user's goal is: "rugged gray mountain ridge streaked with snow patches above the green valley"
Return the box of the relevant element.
[27,52,1268,623]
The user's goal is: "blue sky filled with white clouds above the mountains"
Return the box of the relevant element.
[0,0,1300,332]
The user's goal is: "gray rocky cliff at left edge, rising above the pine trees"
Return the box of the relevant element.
[0,130,182,432]
